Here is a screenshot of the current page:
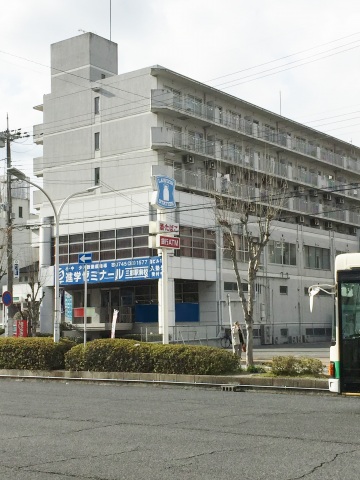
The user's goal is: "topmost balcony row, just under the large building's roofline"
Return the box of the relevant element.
[151,89,360,173]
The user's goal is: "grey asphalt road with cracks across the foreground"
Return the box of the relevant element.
[0,380,360,480]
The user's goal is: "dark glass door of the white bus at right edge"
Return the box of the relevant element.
[337,270,360,393]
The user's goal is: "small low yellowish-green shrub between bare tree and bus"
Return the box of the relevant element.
[271,355,324,377]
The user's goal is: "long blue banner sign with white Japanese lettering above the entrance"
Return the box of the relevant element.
[59,257,162,285]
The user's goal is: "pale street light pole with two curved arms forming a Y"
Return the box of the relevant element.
[7,168,100,342]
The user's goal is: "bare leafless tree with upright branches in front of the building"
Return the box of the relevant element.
[215,171,287,366]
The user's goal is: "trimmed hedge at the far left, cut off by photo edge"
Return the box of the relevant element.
[0,337,74,370]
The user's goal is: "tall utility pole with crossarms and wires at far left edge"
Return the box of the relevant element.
[0,115,30,336]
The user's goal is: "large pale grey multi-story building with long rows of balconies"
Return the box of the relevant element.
[34,33,360,343]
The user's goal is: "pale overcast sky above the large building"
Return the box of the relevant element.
[0,0,360,178]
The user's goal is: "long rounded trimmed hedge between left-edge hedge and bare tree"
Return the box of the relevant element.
[65,339,239,375]
